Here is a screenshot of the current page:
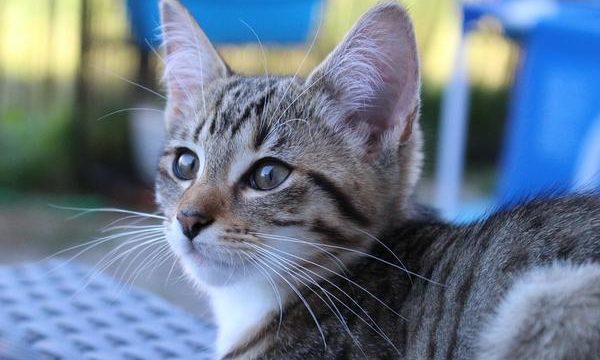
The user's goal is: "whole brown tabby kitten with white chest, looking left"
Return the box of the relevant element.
[156,0,600,359]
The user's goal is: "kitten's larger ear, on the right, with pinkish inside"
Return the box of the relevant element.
[307,2,421,155]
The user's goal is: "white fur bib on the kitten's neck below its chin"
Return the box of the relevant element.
[209,278,287,358]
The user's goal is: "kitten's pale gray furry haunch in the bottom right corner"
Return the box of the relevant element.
[478,261,600,360]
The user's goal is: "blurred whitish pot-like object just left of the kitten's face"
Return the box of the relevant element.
[129,103,165,184]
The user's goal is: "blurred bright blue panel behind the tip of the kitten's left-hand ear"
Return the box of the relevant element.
[127,0,323,47]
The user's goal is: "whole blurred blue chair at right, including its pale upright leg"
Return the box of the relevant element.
[436,0,600,220]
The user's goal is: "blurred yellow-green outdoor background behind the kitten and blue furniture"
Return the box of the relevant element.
[0,0,588,312]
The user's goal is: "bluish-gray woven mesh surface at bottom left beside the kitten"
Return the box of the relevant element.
[0,260,215,360]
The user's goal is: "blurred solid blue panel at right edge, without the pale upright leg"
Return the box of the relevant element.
[498,3,600,204]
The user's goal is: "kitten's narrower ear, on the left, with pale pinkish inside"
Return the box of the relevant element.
[160,0,230,117]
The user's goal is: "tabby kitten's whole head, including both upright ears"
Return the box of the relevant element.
[156,0,421,286]
